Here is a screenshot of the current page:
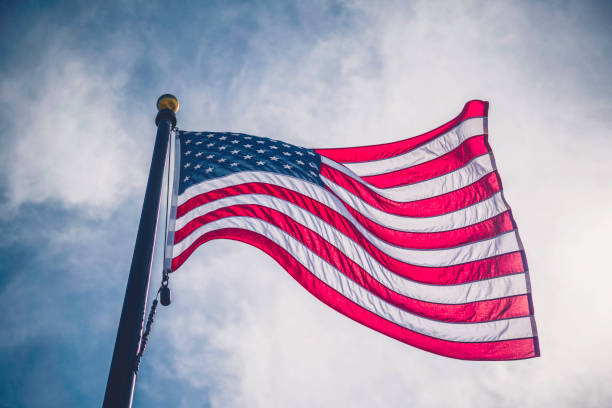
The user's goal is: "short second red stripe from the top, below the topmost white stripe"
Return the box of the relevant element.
[362,135,488,188]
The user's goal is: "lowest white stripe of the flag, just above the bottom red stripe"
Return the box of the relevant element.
[171,217,533,342]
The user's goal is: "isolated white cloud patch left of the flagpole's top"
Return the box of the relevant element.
[0,49,151,214]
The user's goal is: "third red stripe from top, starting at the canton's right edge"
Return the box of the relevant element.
[321,164,500,217]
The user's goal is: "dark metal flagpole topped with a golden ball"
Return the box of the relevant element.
[103,94,179,408]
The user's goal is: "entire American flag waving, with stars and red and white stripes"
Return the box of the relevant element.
[172,101,539,360]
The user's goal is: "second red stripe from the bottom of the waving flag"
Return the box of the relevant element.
[173,210,529,322]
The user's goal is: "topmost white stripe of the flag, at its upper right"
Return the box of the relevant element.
[343,117,487,177]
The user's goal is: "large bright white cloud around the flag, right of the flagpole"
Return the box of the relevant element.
[148,2,612,407]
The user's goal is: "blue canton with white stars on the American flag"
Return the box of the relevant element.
[179,130,323,194]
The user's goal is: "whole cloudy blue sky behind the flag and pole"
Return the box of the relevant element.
[0,0,612,408]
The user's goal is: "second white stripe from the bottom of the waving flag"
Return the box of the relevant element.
[175,196,527,304]
